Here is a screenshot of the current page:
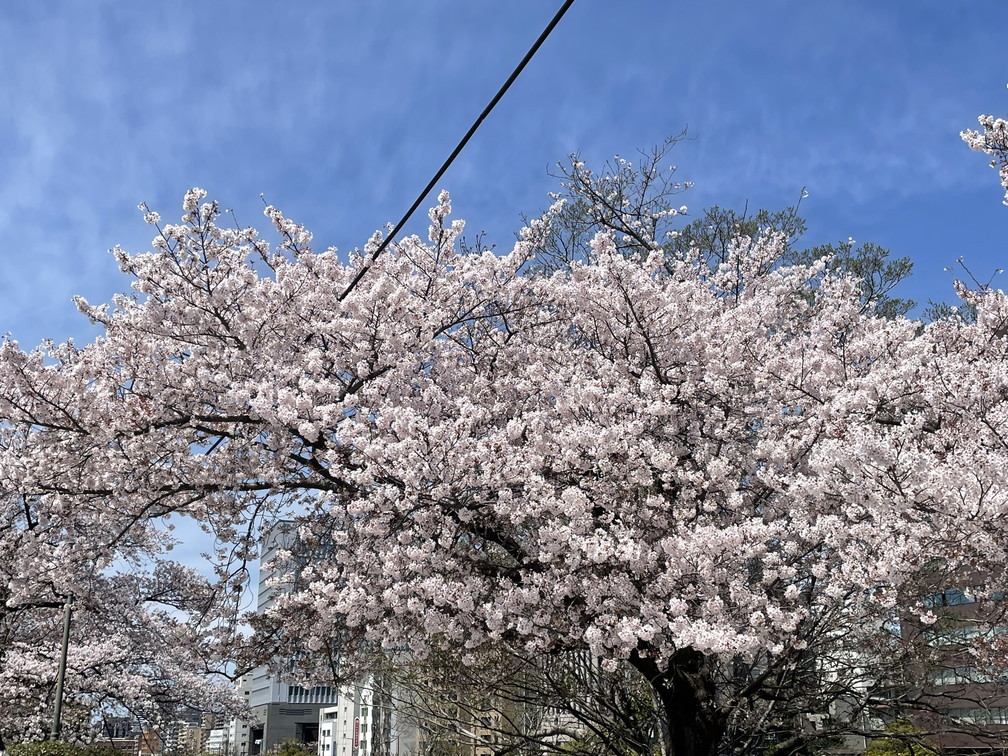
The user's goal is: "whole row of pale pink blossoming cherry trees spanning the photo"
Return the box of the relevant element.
[0,102,1008,756]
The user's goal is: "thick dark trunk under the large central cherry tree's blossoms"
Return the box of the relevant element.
[630,648,725,756]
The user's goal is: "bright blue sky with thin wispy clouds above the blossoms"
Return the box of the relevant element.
[0,0,1008,347]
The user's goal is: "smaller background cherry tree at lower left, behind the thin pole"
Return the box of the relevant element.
[0,496,240,742]
